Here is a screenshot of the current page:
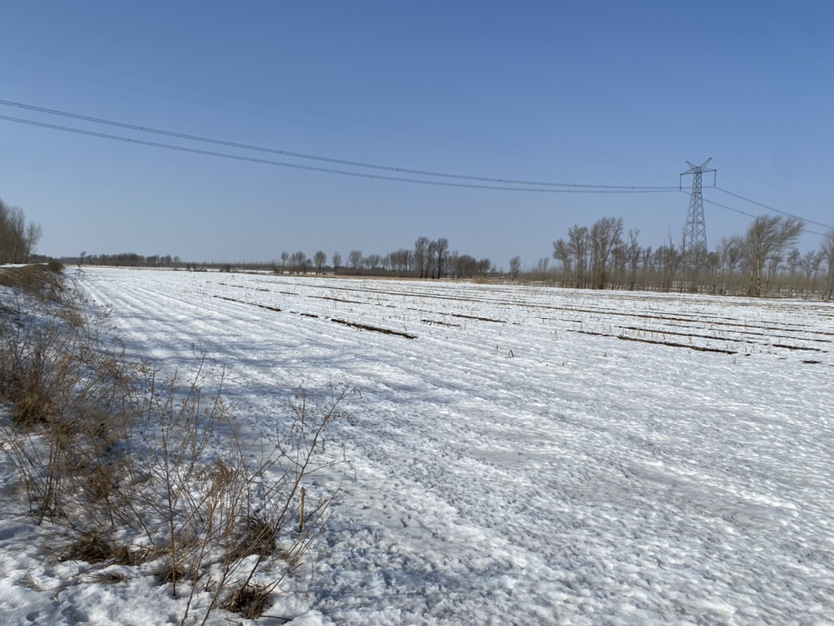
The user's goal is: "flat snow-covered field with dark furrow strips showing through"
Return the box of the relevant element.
[0,269,834,625]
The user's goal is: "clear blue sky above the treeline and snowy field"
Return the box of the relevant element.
[0,0,834,267]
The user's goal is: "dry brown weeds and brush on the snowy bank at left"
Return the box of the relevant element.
[0,266,346,623]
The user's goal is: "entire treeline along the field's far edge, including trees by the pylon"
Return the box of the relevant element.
[58,216,834,300]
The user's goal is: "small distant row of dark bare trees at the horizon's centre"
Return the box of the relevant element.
[274,236,493,278]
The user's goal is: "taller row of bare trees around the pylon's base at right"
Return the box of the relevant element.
[544,215,834,299]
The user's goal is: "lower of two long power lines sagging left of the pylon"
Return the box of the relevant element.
[0,115,679,194]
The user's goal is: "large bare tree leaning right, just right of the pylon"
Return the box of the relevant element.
[744,215,805,296]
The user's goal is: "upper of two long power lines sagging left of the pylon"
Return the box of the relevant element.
[0,100,676,192]
